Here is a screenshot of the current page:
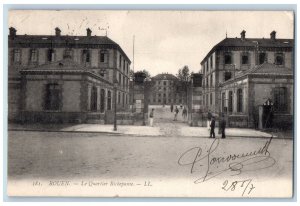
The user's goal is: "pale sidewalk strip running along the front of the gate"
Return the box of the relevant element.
[8,123,292,139]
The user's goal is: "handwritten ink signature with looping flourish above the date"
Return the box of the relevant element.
[178,137,276,184]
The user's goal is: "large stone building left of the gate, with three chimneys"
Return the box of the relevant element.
[8,28,131,123]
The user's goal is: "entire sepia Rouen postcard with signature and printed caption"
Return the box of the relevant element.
[4,9,296,199]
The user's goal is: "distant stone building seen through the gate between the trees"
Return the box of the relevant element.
[149,73,187,105]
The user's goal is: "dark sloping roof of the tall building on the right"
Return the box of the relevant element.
[201,38,294,64]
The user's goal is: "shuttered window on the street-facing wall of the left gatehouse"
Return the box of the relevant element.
[45,84,60,110]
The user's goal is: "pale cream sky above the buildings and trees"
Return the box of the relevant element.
[8,10,294,76]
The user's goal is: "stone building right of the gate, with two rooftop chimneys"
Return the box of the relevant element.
[201,31,294,127]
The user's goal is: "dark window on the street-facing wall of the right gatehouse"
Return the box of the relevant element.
[274,87,287,112]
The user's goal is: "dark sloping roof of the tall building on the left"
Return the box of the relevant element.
[9,35,131,63]
